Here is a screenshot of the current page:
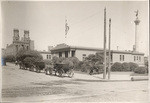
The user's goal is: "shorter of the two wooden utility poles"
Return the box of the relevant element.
[108,19,111,79]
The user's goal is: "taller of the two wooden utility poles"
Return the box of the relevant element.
[103,8,106,79]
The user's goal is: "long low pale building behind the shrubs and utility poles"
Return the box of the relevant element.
[51,44,144,65]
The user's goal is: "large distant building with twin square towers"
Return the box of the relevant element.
[5,29,34,56]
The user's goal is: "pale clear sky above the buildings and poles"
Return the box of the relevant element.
[1,1,149,55]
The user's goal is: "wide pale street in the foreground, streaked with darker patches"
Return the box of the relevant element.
[2,63,148,102]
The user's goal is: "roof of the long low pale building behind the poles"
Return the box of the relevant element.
[51,43,144,55]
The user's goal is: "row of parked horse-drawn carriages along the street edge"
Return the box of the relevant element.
[16,61,74,78]
